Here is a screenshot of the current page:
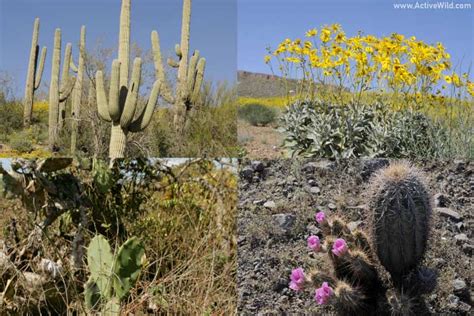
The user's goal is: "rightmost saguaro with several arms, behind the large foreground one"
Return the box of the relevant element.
[151,0,206,133]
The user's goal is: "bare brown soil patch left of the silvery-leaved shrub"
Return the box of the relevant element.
[238,120,285,159]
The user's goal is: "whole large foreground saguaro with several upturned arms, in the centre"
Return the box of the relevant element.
[96,0,161,160]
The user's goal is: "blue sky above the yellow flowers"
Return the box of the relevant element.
[241,0,474,76]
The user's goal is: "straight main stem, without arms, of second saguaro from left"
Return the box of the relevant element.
[49,29,61,151]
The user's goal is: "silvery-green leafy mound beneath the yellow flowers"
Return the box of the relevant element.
[281,101,447,159]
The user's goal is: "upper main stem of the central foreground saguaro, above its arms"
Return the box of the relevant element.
[118,0,131,87]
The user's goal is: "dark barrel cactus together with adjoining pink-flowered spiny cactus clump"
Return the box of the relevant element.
[290,163,436,315]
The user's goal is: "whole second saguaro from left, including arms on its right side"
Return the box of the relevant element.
[49,29,76,151]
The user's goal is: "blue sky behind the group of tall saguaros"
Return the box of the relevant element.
[0,0,237,95]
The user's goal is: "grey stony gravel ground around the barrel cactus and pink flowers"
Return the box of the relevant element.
[238,159,474,315]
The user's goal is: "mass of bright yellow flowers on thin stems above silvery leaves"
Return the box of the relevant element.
[264,24,474,105]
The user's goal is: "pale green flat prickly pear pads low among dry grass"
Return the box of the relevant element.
[84,235,145,315]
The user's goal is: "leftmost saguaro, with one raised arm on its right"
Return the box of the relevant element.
[23,18,47,127]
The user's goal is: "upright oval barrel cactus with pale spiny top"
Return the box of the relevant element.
[370,163,432,287]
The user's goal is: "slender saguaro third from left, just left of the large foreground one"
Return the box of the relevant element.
[71,26,86,155]
